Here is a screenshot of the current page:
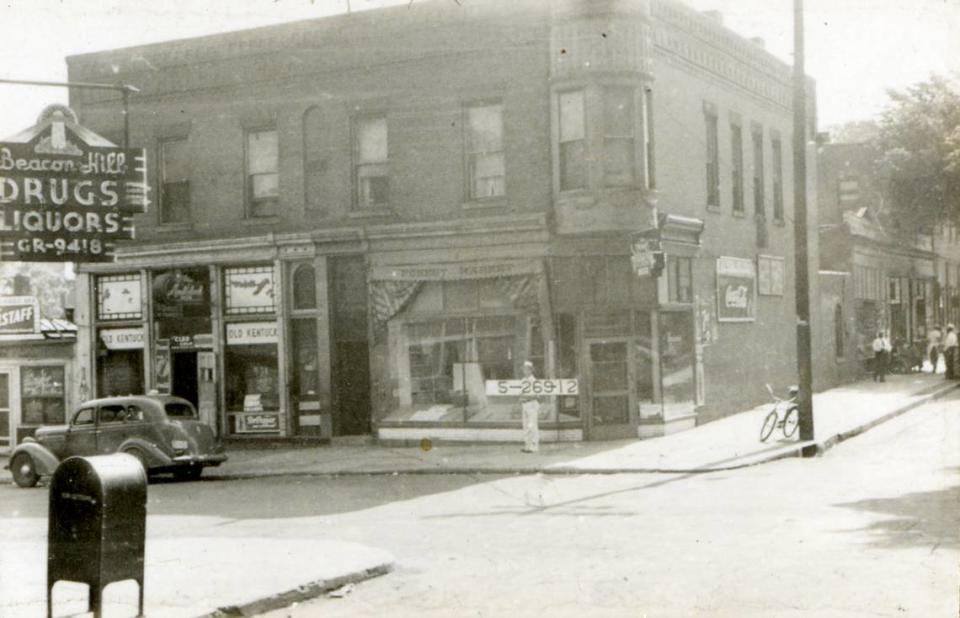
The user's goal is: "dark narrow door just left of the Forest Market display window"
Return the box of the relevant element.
[333,341,370,436]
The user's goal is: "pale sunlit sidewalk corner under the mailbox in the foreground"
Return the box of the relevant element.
[0,520,393,618]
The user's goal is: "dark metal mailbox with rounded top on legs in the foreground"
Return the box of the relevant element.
[47,453,147,618]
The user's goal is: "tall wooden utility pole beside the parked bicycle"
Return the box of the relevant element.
[793,0,815,446]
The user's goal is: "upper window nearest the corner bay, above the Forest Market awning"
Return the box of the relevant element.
[466,103,506,200]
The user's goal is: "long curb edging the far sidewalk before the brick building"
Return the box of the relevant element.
[205,383,960,481]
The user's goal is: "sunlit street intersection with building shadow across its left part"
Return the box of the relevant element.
[0,394,960,618]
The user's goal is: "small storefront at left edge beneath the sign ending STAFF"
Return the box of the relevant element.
[0,297,77,452]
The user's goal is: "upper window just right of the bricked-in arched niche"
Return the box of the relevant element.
[354,116,390,208]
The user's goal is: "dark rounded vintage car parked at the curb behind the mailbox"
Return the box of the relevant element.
[7,395,227,487]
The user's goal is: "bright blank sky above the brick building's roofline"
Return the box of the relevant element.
[0,0,960,139]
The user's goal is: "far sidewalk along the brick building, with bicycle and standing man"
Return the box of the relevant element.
[205,374,960,479]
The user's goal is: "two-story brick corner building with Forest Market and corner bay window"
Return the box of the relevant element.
[68,0,815,442]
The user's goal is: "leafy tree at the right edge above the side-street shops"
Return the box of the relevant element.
[873,75,960,231]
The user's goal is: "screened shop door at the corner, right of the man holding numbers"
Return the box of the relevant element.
[586,338,637,440]
